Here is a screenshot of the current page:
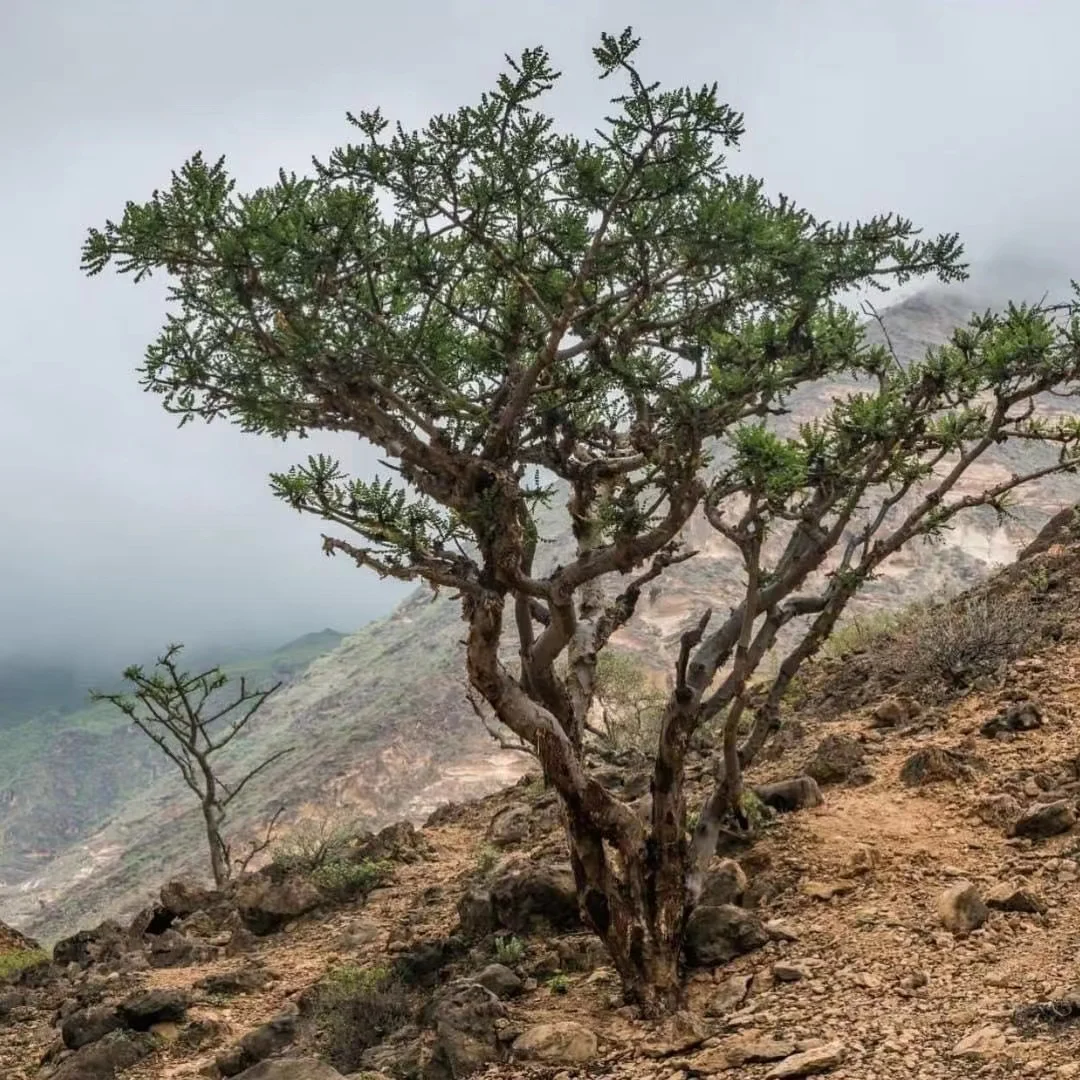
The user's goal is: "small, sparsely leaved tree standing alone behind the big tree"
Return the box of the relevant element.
[91,645,293,888]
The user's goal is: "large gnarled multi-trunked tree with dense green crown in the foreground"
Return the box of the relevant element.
[83,30,1080,1014]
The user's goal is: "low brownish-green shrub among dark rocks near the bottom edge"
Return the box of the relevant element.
[315,964,414,1072]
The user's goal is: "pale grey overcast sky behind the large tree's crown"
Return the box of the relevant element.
[0,0,1080,656]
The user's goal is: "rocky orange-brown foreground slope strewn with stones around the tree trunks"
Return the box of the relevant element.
[6,535,1080,1080]
